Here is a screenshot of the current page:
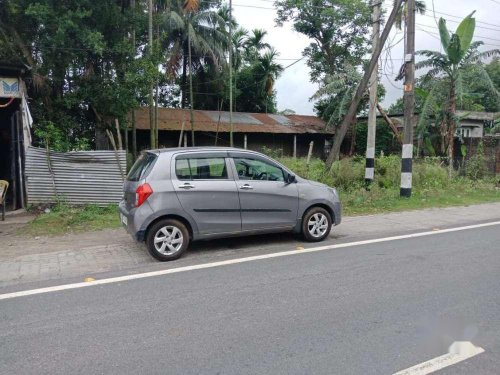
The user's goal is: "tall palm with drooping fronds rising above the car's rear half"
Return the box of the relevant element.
[165,0,230,145]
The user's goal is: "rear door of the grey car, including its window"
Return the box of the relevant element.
[171,153,241,235]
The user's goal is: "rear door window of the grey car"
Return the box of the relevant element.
[175,158,227,180]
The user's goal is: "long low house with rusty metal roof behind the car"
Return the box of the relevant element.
[135,108,333,157]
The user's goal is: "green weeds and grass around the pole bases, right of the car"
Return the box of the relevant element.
[279,155,500,216]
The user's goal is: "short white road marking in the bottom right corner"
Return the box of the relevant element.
[393,341,484,375]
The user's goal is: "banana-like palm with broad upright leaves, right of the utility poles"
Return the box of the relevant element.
[415,12,500,176]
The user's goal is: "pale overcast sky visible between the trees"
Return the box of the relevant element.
[233,0,500,114]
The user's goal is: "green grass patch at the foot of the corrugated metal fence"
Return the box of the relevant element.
[26,204,120,236]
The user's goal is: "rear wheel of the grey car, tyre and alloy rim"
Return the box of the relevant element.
[146,219,190,262]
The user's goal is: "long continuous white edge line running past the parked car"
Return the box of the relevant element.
[0,221,500,300]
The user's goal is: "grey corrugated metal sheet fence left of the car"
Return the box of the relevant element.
[25,147,127,204]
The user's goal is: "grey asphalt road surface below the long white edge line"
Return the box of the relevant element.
[0,225,500,374]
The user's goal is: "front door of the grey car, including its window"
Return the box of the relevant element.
[230,153,298,231]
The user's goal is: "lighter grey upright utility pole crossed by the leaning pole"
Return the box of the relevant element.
[365,0,382,186]
